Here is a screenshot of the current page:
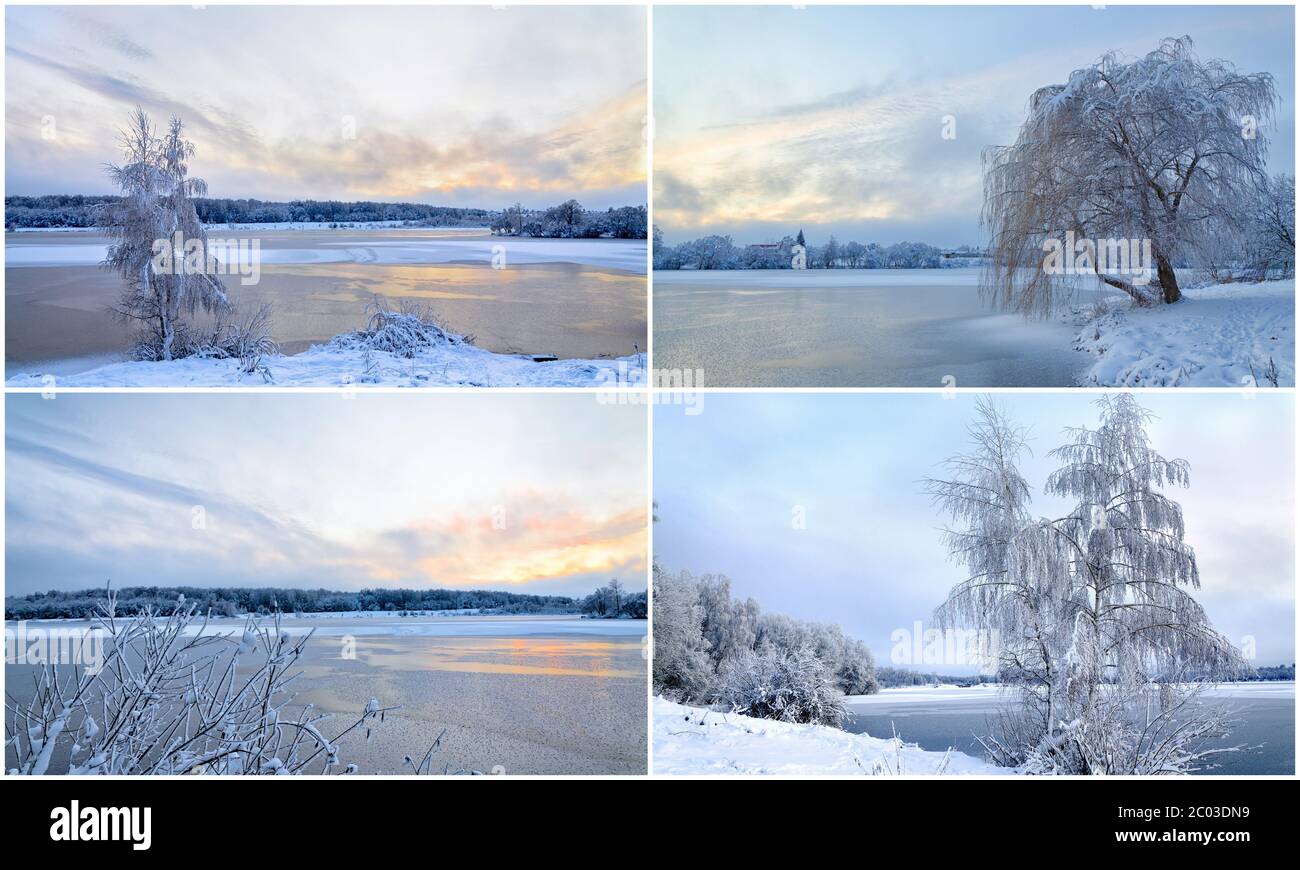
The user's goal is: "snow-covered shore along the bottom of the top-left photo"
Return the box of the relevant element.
[5,345,646,389]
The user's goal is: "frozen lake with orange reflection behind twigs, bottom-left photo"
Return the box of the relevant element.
[5,614,647,774]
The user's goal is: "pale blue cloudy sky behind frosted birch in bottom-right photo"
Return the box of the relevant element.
[654,393,1295,672]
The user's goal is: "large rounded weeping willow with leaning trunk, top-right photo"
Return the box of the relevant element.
[982,36,1278,316]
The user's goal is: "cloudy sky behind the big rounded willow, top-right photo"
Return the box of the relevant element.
[654,5,1295,244]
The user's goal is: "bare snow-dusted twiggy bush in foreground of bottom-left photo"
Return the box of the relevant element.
[5,590,393,775]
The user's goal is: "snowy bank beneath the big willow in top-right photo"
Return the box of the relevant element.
[1075,280,1296,388]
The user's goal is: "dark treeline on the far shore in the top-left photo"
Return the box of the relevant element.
[4,194,646,239]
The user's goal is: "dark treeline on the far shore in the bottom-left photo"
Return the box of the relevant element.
[4,580,646,620]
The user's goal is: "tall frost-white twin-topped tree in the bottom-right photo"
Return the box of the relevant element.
[927,394,1243,774]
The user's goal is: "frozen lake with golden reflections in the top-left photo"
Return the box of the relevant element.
[5,229,647,377]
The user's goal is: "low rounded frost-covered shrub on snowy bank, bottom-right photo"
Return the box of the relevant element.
[715,646,848,727]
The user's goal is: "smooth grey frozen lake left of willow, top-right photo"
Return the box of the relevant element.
[654,268,1100,388]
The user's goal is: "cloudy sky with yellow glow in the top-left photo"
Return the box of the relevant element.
[5,7,646,208]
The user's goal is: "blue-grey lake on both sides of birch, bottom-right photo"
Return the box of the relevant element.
[844,683,1295,774]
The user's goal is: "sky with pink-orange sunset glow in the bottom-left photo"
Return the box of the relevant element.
[5,393,646,594]
